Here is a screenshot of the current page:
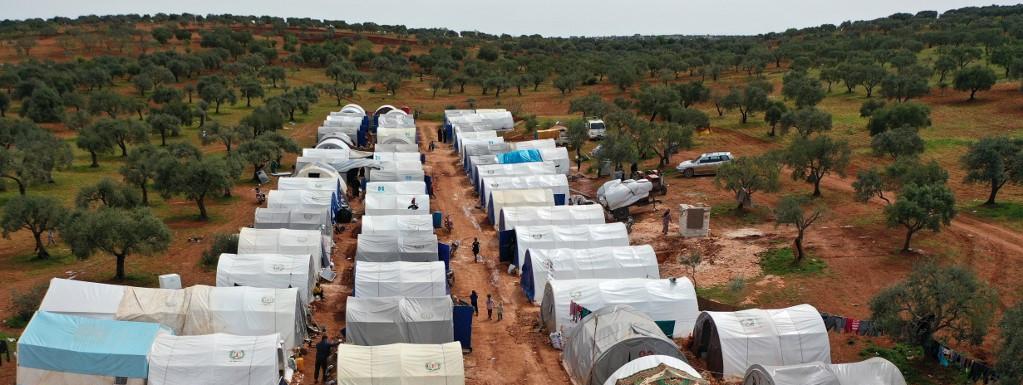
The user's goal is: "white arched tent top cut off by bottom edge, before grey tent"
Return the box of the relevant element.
[604,354,707,385]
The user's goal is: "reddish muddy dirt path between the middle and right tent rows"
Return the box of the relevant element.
[417,121,569,385]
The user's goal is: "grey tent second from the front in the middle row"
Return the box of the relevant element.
[345,296,454,346]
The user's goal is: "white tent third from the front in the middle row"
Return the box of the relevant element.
[354,261,448,297]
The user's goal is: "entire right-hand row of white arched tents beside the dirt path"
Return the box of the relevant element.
[446,111,904,385]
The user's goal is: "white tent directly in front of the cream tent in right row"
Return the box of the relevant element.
[497,205,605,231]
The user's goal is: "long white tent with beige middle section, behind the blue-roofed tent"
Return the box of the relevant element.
[40,280,306,348]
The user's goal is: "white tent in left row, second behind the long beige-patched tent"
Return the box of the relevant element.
[238,227,330,272]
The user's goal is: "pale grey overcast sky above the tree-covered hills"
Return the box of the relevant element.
[0,0,1020,36]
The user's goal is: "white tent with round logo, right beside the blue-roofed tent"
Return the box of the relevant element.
[148,333,284,385]
